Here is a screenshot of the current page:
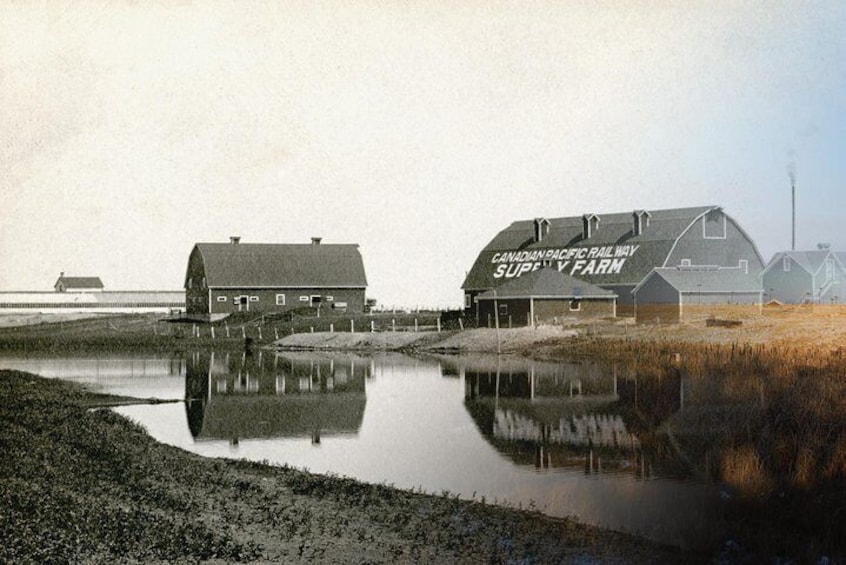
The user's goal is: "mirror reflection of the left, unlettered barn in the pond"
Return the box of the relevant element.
[185,352,372,443]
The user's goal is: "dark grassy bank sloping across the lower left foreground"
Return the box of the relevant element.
[0,371,688,563]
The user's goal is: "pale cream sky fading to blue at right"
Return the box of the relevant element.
[0,0,846,307]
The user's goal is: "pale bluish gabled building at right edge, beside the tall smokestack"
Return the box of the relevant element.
[761,244,846,304]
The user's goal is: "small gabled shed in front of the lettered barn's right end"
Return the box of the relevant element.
[632,267,764,323]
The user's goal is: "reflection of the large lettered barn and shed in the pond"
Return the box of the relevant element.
[460,357,681,475]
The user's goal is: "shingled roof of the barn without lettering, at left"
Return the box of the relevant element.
[191,243,367,288]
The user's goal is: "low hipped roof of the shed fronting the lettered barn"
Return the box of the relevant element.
[479,267,617,300]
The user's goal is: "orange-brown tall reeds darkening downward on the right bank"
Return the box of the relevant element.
[533,338,846,562]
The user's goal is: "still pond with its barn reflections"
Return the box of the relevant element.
[0,351,724,548]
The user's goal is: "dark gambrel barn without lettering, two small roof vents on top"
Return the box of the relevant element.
[185,237,367,320]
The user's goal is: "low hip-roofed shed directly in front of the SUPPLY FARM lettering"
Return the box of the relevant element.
[476,268,617,327]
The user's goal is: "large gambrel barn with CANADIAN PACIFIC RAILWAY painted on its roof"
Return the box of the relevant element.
[462,206,764,316]
